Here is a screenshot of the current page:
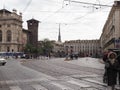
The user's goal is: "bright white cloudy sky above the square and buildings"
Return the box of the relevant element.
[0,0,114,41]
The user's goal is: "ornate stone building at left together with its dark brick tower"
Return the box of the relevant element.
[0,9,39,52]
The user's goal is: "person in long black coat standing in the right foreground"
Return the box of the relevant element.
[105,52,117,90]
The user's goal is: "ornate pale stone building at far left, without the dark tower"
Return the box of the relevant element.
[0,9,23,52]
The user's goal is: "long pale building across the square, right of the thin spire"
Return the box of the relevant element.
[64,40,100,56]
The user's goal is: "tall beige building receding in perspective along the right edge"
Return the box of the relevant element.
[100,1,120,51]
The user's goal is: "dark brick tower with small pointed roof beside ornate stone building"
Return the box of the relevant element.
[27,19,39,47]
